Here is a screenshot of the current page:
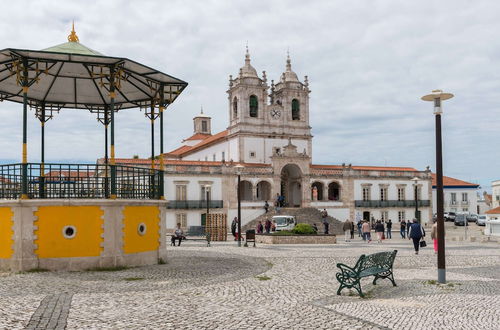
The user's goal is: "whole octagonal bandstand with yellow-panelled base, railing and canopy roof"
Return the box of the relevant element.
[0,27,187,271]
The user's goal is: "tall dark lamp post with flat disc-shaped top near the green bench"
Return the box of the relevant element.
[422,89,453,283]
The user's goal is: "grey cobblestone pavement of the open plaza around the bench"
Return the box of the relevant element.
[0,235,500,329]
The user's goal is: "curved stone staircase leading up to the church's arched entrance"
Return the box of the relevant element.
[241,207,344,236]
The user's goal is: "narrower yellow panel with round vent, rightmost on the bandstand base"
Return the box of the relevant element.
[123,206,160,254]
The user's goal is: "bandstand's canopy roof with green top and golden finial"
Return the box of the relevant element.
[0,24,187,111]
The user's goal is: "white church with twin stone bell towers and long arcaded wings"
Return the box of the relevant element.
[117,49,432,228]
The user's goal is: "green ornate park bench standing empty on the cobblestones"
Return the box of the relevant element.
[336,250,398,297]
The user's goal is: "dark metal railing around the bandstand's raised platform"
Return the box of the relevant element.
[0,163,163,199]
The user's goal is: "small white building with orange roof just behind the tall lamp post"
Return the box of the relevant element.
[432,173,481,214]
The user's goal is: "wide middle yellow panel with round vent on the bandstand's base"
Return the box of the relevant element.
[35,206,104,258]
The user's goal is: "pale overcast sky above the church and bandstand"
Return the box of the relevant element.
[0,0,500,190]
